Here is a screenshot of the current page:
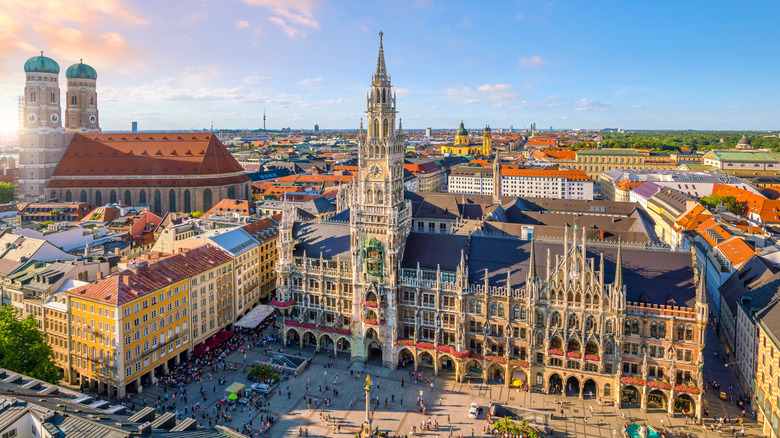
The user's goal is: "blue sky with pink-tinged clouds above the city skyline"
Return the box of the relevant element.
[0,0,780,133]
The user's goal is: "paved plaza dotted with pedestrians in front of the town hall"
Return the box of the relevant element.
[79,320,761,437]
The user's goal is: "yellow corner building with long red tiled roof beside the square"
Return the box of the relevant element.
[64,246,233,397]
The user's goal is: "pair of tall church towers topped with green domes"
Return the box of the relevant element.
[19,52,100,202]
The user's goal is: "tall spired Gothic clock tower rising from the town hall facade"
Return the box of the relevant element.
[350,32,412,366]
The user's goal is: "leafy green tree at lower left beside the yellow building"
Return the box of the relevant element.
[0,305,60,383]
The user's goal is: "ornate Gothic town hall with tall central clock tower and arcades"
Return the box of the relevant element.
[273,34,707,414]
